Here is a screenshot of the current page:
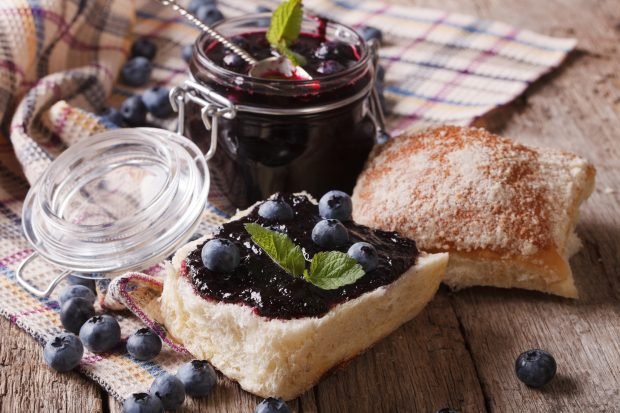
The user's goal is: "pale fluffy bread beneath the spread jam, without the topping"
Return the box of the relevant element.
[161,200,448,400]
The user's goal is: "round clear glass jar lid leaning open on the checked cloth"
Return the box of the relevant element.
[22,128,209,273]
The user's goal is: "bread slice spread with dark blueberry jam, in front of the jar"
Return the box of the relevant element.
[161,194,448,400]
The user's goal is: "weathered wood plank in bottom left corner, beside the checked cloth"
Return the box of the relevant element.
[0,317,103,413]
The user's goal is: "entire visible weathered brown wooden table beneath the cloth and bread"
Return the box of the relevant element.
[0,0,620,413]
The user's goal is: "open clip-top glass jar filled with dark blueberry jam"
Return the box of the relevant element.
[176,14,378,209]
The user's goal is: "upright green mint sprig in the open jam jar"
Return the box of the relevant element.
[267,0,306,66]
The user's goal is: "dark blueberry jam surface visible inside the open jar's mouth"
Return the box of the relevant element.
[205,32,361,80]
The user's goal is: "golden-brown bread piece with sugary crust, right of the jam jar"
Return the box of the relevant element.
[352,126,595,297]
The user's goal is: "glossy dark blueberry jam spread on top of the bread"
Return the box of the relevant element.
[185,195,418,319]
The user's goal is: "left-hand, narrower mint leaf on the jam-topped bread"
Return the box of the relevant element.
[244,223,306,277]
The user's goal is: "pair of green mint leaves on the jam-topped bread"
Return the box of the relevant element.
[244,223,365,290]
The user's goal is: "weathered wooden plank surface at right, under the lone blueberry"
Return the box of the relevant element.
[424,0,620,412]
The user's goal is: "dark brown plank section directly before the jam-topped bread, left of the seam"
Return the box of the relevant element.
[315,292,486,413]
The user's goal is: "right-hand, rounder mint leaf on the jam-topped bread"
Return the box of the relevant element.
[304,251,365,290]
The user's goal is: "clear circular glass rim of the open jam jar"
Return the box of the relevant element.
[194,13,371,90]
